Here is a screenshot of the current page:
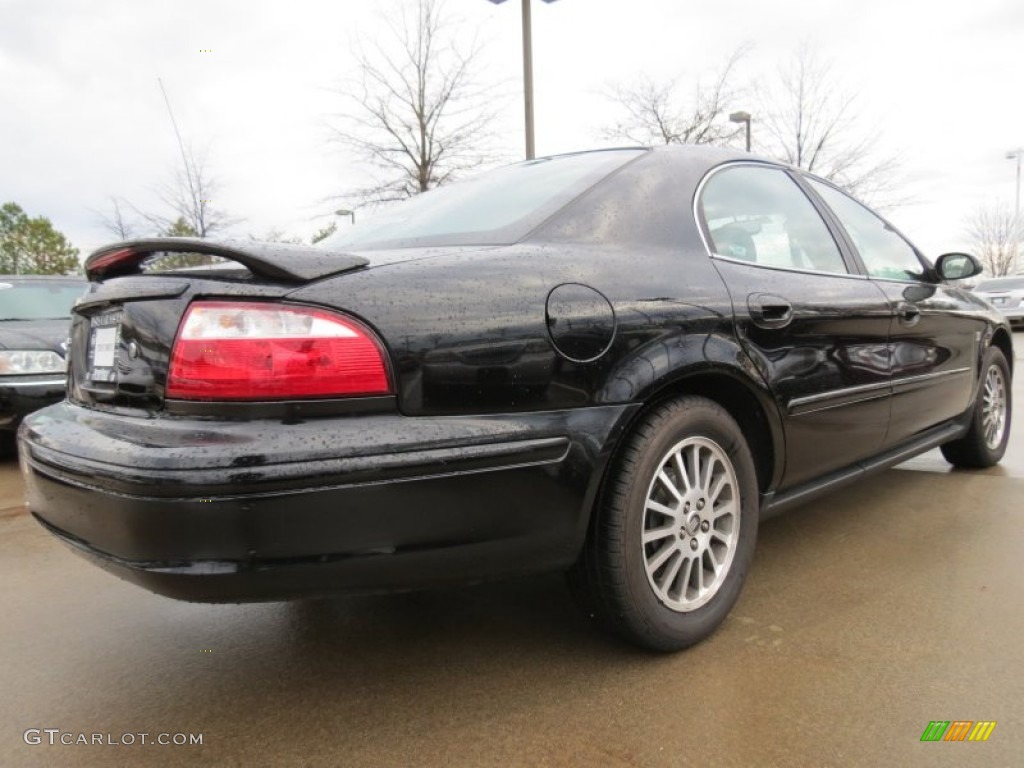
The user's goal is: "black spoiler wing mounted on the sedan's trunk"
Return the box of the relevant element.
[85,238,370,283]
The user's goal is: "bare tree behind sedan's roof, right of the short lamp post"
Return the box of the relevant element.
[755,44,903,207]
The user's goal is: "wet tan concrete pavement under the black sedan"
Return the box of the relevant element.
[0,334,1024,767]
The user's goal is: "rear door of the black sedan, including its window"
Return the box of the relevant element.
[696,163,891,488]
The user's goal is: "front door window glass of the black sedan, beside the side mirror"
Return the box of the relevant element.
[807,178,925,281]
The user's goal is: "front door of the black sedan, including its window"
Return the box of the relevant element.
[807,178,985,445]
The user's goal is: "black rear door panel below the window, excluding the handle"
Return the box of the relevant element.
[715,259,890,489]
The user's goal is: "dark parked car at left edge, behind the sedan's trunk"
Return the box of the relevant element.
[0,274,88,456]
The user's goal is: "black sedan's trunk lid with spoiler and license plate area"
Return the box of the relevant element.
[69,238,370,413]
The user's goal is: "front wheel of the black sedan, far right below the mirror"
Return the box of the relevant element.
[941,347,1013,469]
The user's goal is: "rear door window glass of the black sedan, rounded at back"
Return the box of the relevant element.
[699,166,849,273]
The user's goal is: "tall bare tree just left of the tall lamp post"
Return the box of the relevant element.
[334,0,495,202]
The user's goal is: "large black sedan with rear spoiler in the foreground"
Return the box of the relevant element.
[19,147,1013,650]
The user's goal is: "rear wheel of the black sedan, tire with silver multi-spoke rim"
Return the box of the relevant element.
[569,396,759,651]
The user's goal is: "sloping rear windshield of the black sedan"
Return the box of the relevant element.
[323,150,644,250]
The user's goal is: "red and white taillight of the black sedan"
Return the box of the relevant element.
[167,301,391,400]
